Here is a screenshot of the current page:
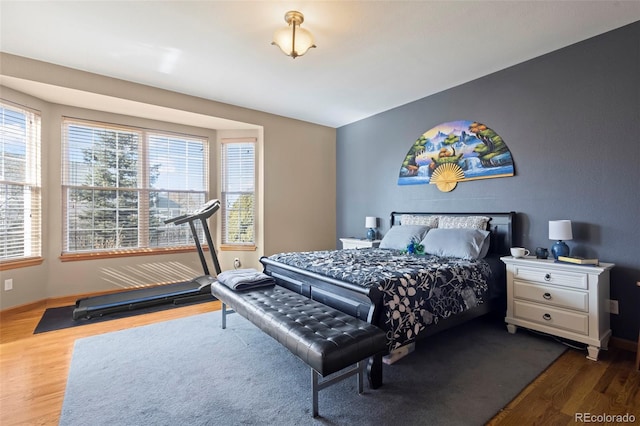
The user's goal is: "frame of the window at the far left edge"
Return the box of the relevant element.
[0,99,44,271]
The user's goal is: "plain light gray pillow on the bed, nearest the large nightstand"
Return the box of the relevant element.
[421,228,490,259]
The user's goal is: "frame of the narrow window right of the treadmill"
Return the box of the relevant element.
[219,137,258,251]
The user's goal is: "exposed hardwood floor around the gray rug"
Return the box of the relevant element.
[0,300,640,426]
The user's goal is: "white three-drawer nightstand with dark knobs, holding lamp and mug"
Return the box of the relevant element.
[501,256,614,361]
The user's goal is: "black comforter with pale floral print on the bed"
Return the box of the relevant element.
[269,249,491,350]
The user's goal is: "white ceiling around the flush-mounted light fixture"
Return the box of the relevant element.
[0,0,640,127]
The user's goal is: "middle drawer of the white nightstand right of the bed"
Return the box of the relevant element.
[513,280,589,312]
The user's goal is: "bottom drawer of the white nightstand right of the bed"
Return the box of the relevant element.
[513,300,589,336]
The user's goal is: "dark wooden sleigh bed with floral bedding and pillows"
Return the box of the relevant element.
[261,212,515,387]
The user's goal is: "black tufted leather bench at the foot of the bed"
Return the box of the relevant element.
[211,281,386,417]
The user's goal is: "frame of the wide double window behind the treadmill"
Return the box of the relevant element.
[59,117,211,262]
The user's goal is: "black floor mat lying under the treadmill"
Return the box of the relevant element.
[33,296,217,334]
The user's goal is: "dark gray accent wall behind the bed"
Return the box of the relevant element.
[337,22,640,340]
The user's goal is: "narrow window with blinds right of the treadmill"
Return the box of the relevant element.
[221,138,256,249]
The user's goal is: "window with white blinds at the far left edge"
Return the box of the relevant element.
[0,102,42,263]
